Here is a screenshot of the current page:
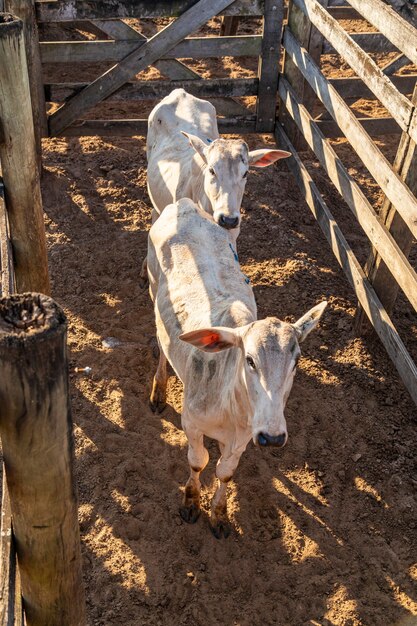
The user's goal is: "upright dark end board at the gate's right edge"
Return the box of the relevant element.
[256,0,284,133]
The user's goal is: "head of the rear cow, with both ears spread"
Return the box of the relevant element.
[182,131,290,230]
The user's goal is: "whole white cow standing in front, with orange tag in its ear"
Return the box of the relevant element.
[148,198,327,538]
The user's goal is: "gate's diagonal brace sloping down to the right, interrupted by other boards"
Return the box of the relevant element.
[94,20,249,116]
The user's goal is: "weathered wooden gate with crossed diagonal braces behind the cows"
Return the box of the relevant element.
[28,0,283,136]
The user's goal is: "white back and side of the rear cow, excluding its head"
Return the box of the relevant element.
[147,89,219,213]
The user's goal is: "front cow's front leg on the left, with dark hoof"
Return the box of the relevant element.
[180,427,209,524]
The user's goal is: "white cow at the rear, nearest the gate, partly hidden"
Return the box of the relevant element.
[147,89,290,234]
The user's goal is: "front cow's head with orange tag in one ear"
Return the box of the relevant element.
[180,302,327,447]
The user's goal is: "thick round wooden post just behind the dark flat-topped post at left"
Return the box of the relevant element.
[0,13,50,294]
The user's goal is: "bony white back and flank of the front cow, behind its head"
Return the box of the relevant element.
[148,198,256,381]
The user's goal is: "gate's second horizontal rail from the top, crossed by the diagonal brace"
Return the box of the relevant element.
[40,35,262,64]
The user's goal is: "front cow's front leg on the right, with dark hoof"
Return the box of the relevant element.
[210,443,243,539]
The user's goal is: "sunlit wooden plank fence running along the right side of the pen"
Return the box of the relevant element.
[275,0,417,403]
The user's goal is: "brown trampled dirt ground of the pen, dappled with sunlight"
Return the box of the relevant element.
[5,8,417,626]
